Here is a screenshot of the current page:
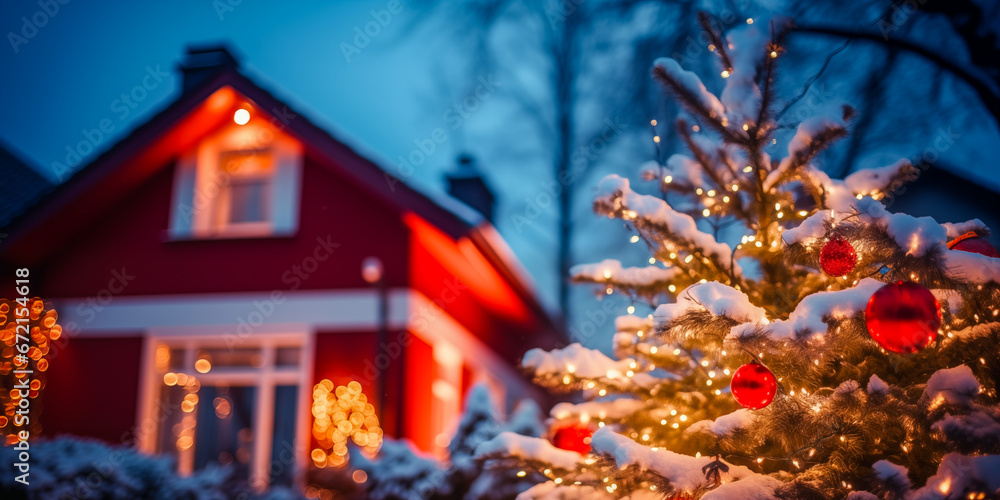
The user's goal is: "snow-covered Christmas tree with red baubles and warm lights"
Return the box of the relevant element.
[477,13,1000,500]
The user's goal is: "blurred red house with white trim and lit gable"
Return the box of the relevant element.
[0,49,565,485]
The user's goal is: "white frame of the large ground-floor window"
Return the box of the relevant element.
[139,332,315,491]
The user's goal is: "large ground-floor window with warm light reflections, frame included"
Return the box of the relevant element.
[147,334,308,487]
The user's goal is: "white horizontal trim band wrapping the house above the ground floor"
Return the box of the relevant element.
[53,287,534,400]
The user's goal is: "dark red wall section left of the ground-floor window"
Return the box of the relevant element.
[41,336,143,444]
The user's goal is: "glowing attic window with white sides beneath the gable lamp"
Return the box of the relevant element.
[169,98,302,239]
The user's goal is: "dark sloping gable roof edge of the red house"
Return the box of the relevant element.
[0,47,565,340]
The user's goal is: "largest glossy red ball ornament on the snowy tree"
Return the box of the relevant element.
[865,281,941,354]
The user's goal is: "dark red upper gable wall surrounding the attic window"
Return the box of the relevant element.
[32,154,407,297]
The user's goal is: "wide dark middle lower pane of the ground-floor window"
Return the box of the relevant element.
[194,386,257,479]
